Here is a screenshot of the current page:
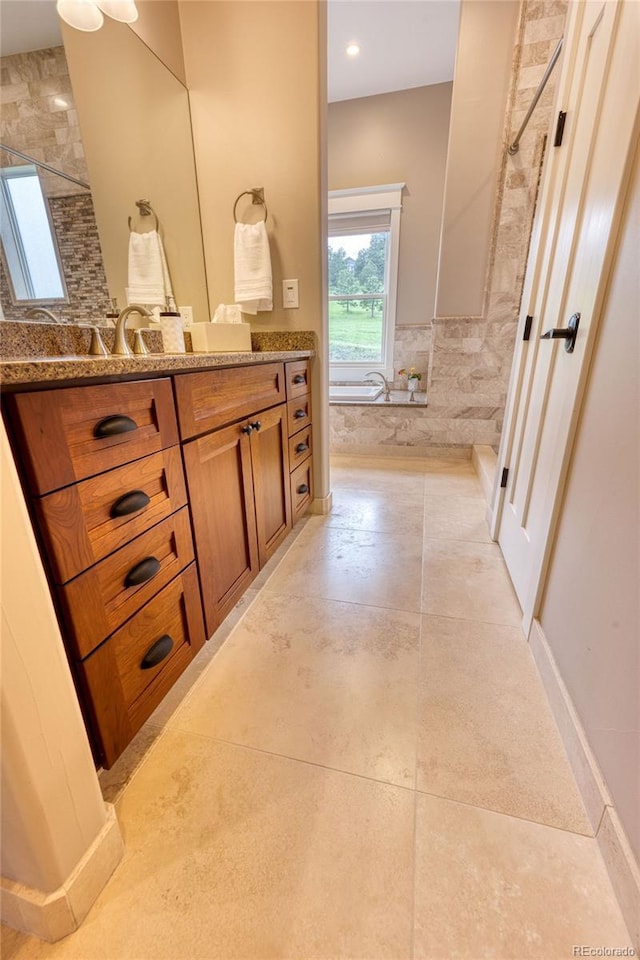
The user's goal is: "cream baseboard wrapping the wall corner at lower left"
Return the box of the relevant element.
[0,803,124,943]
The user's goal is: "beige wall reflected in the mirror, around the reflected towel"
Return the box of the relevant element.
[63,15,209,320]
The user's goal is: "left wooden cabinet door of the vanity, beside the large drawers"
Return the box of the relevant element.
[184,424,258,636]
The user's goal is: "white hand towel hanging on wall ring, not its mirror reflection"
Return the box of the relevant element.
[233,220,273,314]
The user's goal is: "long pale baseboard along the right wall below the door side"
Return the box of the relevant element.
[529,620,640,953]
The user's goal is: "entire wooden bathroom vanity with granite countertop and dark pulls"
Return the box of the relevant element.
[3,351,312,767]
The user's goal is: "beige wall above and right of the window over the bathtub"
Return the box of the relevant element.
[328,83,452,324]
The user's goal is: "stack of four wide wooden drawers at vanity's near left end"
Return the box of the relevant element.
[5,378,205,767]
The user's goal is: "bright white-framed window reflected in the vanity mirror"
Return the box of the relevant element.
[0,166,65,302]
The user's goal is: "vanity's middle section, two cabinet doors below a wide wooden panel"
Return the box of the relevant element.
[176,364,291,634]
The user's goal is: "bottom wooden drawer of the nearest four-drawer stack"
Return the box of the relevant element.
[79,564,205,767]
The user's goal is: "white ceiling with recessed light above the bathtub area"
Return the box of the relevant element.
[327,0,460,101]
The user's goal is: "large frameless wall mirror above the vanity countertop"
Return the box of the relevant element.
[0,0,209,320]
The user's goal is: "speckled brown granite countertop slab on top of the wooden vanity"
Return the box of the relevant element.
[0,350,314,388]
